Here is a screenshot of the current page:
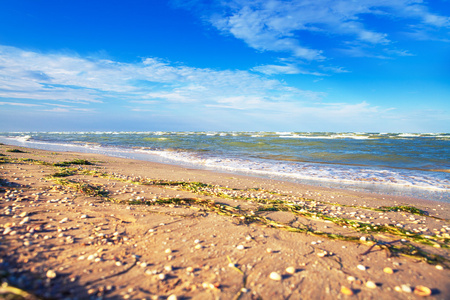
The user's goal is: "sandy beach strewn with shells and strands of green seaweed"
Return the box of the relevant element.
[0,145,450,300]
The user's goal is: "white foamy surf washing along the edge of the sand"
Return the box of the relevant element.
[0,137,450,203]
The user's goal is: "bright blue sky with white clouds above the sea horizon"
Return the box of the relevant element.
[0,0,450,132]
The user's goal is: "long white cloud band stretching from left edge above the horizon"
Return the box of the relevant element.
[0,46,323,109]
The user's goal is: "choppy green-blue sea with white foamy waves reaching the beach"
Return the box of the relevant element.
[0,132,450,202]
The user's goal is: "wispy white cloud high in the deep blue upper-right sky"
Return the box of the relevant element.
[175,0,450,60]
